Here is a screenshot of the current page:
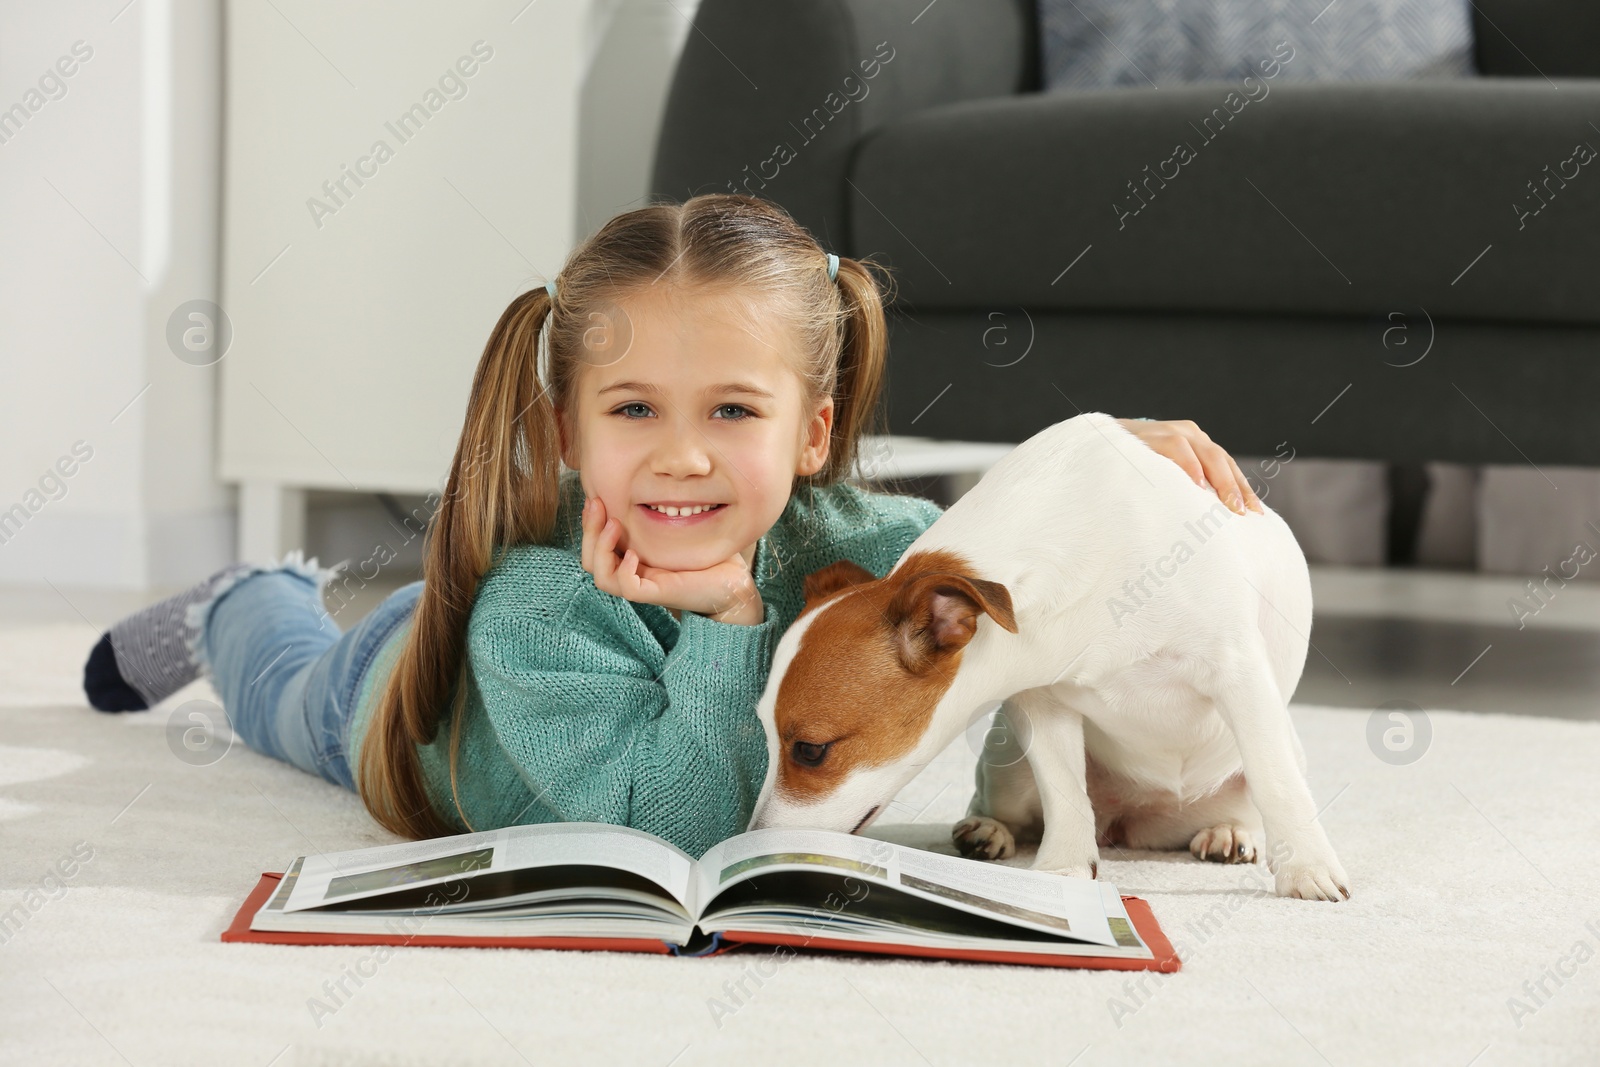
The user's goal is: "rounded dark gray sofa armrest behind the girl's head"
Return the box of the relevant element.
[651,0,1038,253]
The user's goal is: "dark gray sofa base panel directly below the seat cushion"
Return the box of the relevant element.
[886,304,1600,463]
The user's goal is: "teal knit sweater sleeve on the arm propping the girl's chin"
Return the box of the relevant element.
[470,593,778,856]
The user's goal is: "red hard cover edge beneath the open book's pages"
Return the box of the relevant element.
[222,872,1182,971]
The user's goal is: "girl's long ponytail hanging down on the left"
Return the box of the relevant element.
[357,286,562,838]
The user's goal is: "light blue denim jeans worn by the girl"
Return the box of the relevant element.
[200,566,422,790]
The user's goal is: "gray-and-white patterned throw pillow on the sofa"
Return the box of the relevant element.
[1038,0,1475,91]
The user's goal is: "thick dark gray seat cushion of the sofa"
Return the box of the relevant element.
[850,78,1600,323]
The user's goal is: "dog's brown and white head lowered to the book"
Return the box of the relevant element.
[750,552,1016,833]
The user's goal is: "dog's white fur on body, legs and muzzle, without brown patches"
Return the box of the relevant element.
[750,413,1349,901]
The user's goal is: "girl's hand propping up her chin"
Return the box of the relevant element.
[582,496,766,625]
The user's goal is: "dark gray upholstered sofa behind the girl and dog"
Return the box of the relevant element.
[651,0,1600,466]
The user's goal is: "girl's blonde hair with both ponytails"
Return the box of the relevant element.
[357,194,891,838]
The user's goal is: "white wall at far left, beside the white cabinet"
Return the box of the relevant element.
[0,0,232,589]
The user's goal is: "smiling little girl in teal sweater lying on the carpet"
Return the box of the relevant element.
[85,194,1259,856]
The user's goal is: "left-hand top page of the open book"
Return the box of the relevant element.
[283,822,694,912]
